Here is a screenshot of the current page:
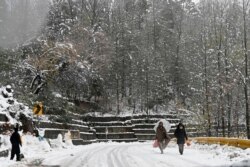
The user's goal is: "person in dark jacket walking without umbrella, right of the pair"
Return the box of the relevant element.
[174,123,188,155]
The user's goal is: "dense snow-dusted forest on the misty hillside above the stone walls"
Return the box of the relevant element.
[0,0,250,138]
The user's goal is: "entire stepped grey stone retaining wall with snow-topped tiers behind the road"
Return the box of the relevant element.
[0,113,200,145]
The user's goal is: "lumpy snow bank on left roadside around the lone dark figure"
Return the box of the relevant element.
[0,133,76,167]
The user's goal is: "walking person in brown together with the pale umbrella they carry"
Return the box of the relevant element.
[155,122,170,154]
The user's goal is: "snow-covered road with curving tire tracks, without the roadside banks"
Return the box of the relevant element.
[43,143,231,167]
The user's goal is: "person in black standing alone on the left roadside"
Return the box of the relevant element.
[10,127,22,161]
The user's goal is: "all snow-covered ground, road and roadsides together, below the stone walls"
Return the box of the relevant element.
[0,136,250,167]
